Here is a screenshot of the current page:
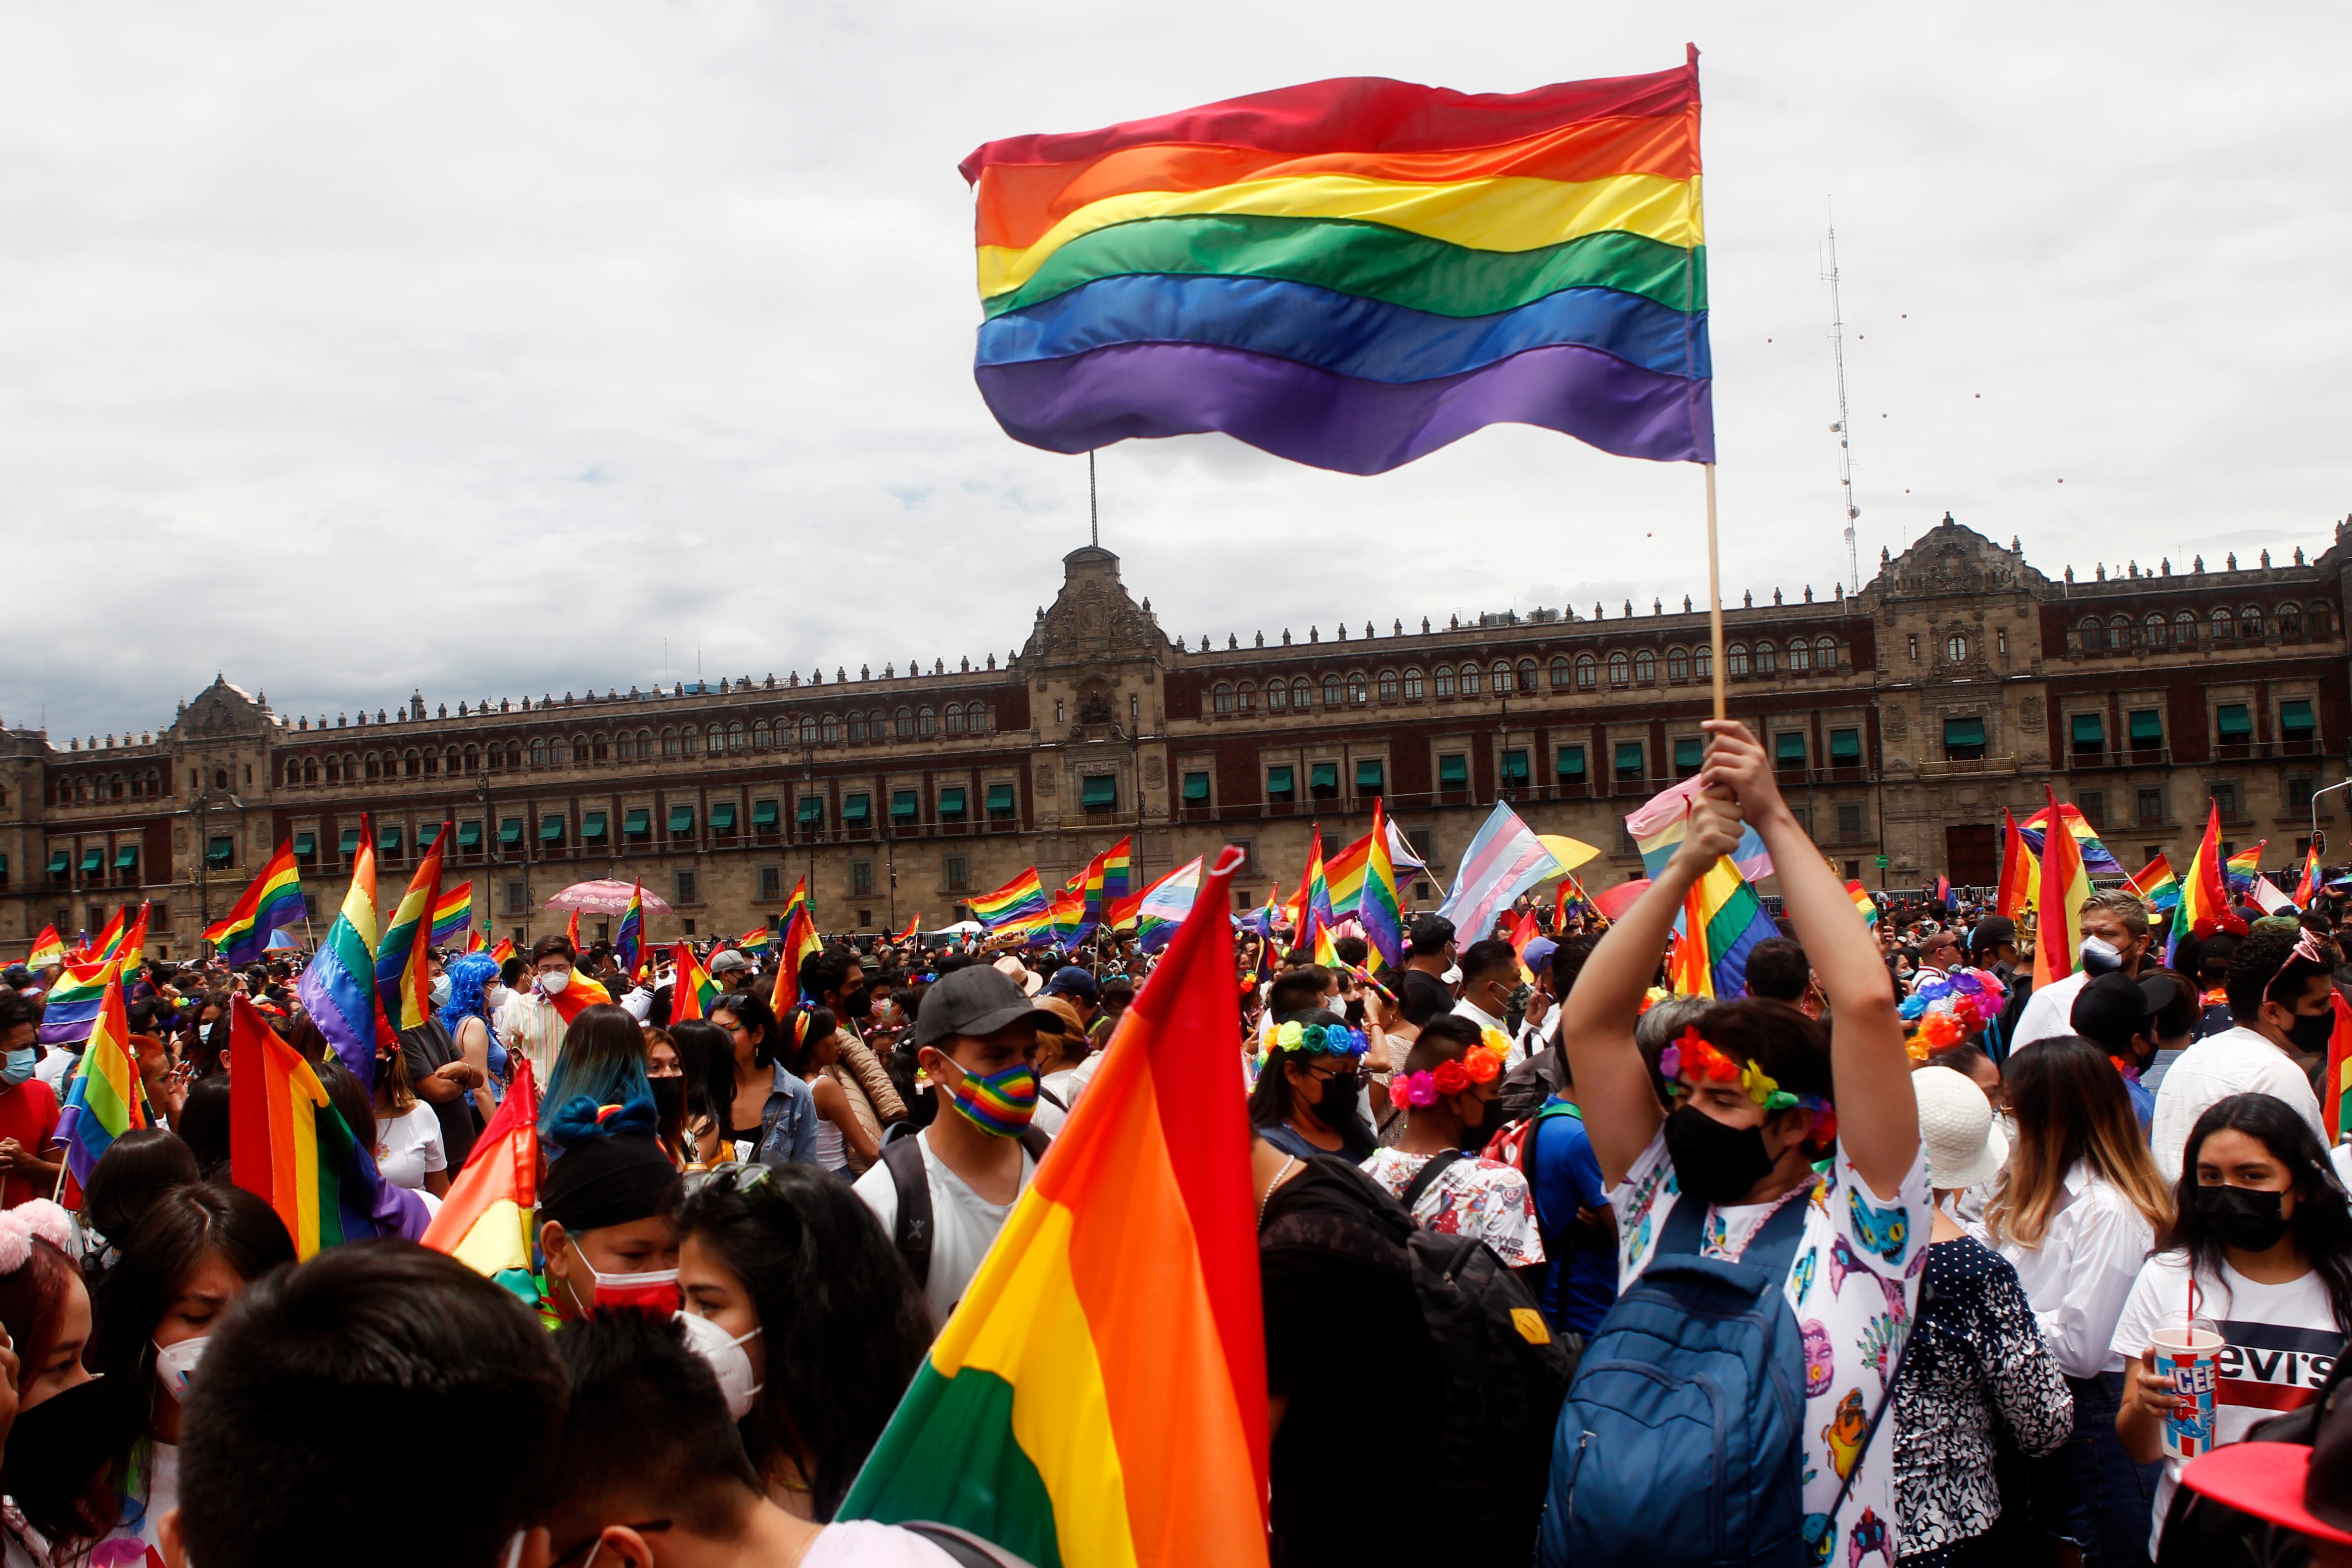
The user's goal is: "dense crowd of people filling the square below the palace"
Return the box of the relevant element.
[0,724,2352,1568]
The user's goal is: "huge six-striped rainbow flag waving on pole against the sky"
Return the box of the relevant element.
[962,49,1715,475]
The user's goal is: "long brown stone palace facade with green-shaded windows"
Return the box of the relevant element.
[0,517,2352,957]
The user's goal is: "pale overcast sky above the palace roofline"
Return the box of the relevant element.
[0,0,2352,745]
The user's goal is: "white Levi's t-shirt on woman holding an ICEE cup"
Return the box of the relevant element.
[2115,1253,2345,1556]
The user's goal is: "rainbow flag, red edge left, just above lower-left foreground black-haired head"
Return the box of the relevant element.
[228,997,383,1260]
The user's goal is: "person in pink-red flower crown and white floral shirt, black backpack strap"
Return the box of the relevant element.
[1364,1013,1543,1270]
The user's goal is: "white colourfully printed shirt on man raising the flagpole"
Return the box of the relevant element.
[1609,1131,1931,1563]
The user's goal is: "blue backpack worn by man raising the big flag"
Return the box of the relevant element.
[1536,1196,1806,1568]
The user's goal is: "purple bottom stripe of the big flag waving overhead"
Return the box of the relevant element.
[976,343,1715,475]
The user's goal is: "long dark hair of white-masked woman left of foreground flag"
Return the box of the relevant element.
[677,1166,932,1523]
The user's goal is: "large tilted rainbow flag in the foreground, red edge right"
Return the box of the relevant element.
[840,849,1268,1568]
